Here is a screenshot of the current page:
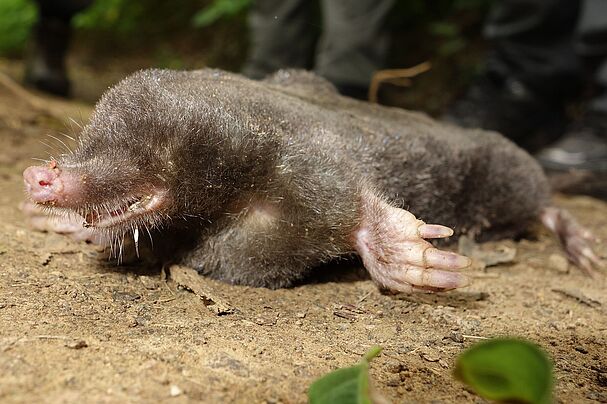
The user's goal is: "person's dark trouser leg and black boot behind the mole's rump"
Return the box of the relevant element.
[445,0,583,148]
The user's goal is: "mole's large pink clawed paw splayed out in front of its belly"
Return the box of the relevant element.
[355,196,470,292]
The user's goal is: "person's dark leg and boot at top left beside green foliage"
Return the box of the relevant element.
[25,0,93,96]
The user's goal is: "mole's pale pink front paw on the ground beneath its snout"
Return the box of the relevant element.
[19,201,103,244]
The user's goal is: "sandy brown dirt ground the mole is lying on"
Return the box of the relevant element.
[0,71,607,403]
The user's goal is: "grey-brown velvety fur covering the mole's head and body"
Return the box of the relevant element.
[65,70,549,288]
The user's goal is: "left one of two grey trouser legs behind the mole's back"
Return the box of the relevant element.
[242,0,316,79]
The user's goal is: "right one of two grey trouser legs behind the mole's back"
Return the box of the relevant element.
[314,0,394,98]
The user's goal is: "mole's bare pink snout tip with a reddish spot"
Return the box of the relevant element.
[23,160,83,207]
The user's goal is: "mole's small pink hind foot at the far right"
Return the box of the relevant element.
[540,206,605,277]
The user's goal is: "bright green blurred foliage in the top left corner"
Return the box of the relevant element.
[0,0,37,55]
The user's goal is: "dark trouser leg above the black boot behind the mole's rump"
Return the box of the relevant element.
[485,0,583,99]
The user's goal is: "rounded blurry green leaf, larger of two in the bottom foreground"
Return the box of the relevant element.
[454,338,552,404]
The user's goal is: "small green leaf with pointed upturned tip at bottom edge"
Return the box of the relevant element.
[308,346,381,404]
